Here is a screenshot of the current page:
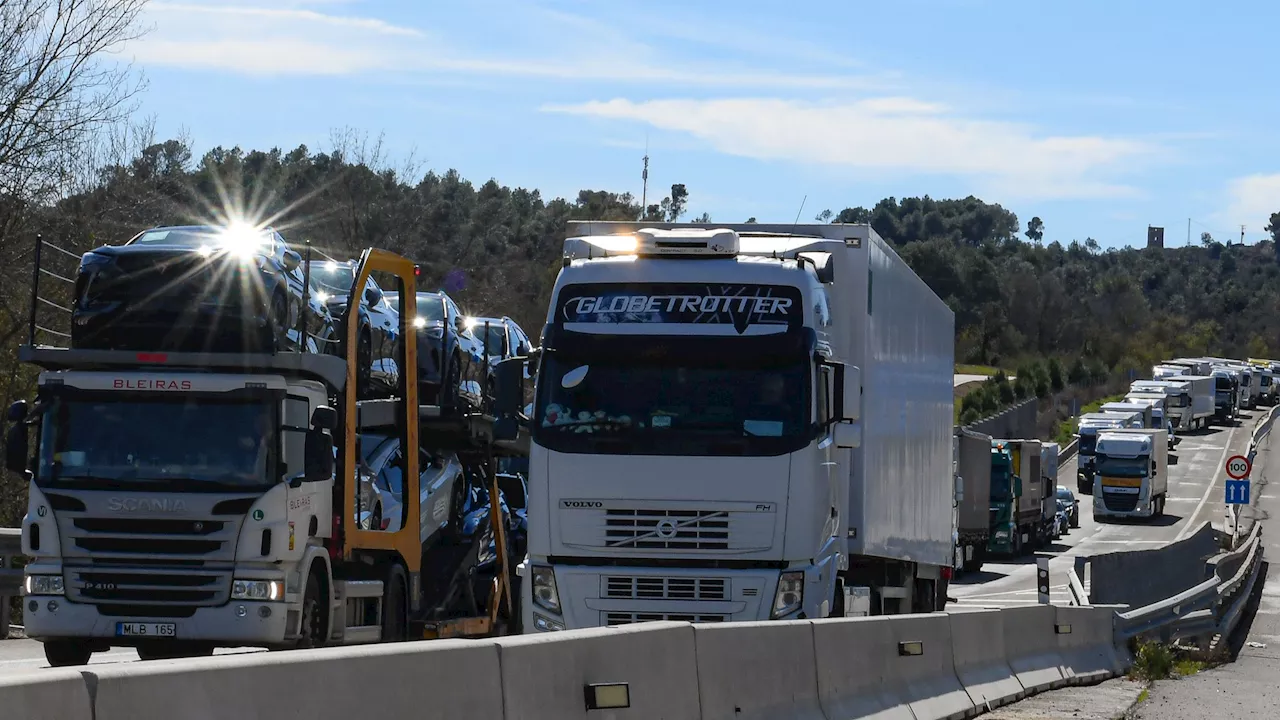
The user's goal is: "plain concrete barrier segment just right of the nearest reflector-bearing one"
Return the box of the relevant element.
[694,620,826,720]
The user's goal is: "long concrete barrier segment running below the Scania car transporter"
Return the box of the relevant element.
[92,641,504,720]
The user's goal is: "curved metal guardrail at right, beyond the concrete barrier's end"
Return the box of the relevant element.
[1116,524,1262,642]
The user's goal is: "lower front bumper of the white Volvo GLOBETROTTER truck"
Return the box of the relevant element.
[520,564,835,632]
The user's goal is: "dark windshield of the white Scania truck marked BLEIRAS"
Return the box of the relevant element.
[36,397,278,491]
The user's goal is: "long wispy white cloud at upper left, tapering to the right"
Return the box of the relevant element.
[131,0,887,91]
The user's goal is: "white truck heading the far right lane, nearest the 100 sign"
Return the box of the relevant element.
[1093,428,1169,520]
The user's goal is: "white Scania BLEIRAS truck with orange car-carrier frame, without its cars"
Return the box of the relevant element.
[5,251,527,666]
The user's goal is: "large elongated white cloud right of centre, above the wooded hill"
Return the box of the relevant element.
[544,97,1160,199]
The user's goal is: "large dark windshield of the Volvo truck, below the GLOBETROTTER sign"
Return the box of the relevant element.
[534,340,813,455]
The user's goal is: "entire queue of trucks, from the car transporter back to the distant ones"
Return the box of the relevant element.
[20,222,1276,665]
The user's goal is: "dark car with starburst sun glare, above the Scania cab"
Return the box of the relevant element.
[70,224,334,352]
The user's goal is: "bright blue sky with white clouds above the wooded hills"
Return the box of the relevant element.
[123,0,1280,246]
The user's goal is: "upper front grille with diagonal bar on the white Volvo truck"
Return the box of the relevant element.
[604,509,730,550]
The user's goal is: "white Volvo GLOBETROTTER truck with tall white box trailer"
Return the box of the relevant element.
[520,222,955,632]
